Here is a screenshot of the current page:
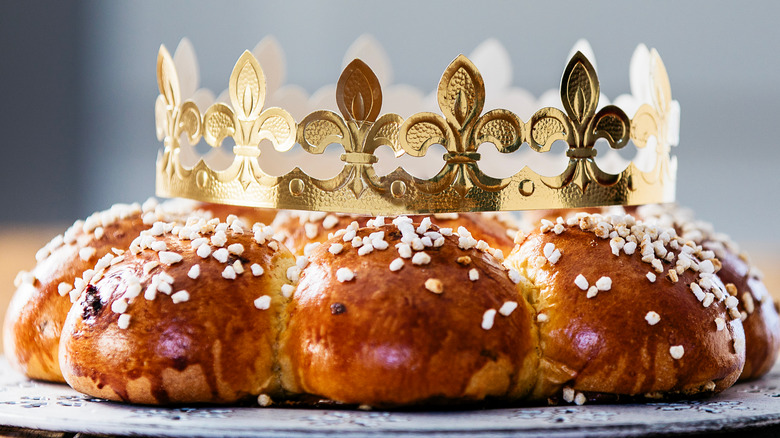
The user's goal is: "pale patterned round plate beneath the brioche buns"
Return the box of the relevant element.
[0,357,780,438]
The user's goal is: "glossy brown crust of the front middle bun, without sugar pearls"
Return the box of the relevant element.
[280,225,538,406]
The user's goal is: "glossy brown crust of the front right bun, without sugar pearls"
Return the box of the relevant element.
[506,219,744,401]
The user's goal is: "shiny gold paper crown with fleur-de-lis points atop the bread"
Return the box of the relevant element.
[155,40,676,215]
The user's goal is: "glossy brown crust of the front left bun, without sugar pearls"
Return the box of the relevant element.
[55,219,294,404]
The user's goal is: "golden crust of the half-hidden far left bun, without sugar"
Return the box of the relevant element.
[3,208,146,382]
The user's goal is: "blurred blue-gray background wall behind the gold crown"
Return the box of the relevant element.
[0,0,780,244]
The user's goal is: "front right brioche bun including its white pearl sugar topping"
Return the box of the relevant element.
[506,213,745,402]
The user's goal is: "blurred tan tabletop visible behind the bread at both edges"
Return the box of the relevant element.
[0,225,780,347]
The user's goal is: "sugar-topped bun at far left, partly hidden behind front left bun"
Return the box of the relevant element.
[3,200,194,382]
